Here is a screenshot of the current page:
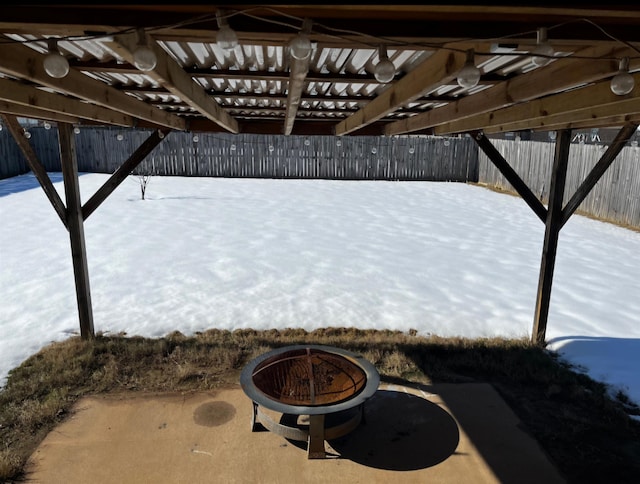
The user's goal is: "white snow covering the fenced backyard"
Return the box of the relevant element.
[0,173,640,410]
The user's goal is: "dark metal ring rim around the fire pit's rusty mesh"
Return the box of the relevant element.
[240,345,380,415]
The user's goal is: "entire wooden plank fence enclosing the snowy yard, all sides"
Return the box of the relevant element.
[0,127,640,229]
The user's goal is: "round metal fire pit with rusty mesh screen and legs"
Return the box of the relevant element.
[240,345,380,459]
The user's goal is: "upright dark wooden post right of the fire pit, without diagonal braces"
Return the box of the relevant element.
[531,130,571,345]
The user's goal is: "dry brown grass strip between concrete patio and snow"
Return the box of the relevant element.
[0,328,640,484]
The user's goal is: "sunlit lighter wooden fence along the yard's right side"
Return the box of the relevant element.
[478,140,640,229]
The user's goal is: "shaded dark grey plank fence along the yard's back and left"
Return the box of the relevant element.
[0,127,478,182]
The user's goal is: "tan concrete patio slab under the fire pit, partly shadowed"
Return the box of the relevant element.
[27,383,564,484]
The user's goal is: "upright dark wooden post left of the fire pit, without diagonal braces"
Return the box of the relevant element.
[58,123,95,339]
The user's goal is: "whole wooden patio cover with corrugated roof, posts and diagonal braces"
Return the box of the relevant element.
[0,2,640,344]
